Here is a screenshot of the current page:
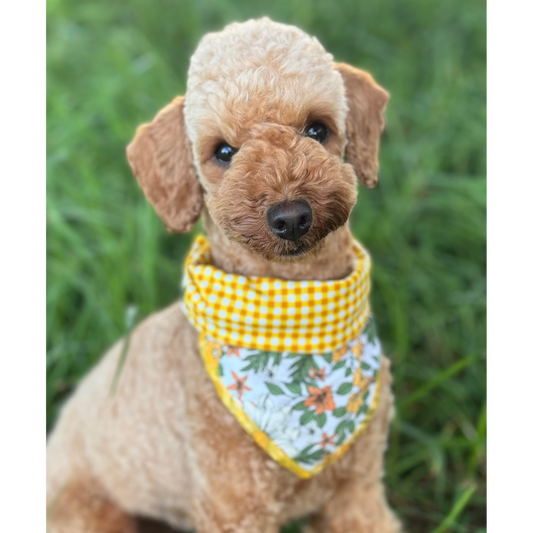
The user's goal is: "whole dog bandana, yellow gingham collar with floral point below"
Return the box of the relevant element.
[183,236,381,479]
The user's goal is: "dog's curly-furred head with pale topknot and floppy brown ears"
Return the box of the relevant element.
[128,19,388,261]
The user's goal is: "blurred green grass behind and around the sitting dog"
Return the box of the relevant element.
[43,0,490,533]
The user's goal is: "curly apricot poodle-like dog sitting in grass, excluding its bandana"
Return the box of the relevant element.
[43,18,401,533]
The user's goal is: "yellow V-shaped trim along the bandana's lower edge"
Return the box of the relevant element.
[200,333,381,479]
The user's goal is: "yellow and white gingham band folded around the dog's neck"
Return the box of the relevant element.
[184,236,371,354]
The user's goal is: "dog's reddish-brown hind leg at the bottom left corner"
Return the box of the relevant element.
[43,482,137,533]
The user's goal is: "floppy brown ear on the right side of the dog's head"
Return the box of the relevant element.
[335,63,389,188]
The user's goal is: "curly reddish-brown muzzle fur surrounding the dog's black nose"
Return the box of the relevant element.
[206,124,357,260]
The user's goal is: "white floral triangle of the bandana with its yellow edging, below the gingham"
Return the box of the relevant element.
[202,319,381,478]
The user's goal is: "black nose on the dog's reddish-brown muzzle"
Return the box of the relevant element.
[267,200,313,241]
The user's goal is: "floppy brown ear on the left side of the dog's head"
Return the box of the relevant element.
[126,96,203,233]
